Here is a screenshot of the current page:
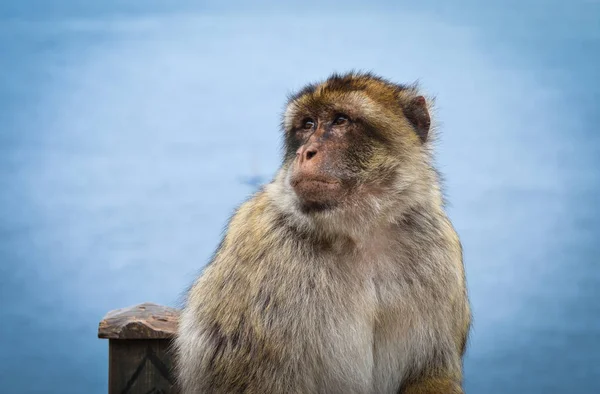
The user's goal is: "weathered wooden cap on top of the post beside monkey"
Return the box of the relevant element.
[98,302,179,339]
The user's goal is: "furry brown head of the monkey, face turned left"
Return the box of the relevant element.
[272,73,431,231]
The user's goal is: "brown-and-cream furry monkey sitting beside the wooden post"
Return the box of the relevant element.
[174,71,471,394]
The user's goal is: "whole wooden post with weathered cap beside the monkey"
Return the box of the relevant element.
[98,303,179,394]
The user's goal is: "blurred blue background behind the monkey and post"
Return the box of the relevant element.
[0,0,600,394]
